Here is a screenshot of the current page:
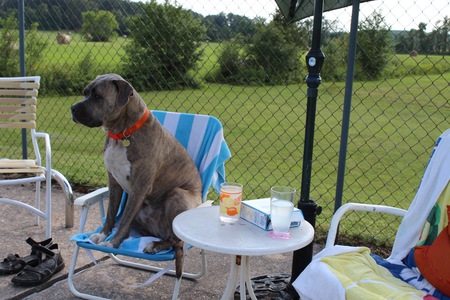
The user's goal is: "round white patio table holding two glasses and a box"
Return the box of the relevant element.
[173,206,314,300]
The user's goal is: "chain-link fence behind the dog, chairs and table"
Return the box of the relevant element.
[0,0,450,247]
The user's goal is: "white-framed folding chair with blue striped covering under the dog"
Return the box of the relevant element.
[69,111,231,299]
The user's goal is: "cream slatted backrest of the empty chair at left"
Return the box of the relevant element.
[0,76,40,129]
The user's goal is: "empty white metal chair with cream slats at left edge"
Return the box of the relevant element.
[0,76,52,238]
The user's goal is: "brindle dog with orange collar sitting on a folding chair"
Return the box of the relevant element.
[72,74,202,278]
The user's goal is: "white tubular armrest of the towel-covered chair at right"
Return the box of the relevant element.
[325,203,407,247]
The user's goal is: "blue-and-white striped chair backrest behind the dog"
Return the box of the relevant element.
[152,111,231,201]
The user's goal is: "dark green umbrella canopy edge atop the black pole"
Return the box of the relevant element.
[275,0,372,22]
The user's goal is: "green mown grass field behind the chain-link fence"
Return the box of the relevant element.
[0,33,450,245]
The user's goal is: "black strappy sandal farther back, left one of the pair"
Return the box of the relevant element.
[0,238,52,275]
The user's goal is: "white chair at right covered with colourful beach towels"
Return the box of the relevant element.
[293,129,450,300]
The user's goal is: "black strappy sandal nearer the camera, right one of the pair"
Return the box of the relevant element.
[11,244,64,286]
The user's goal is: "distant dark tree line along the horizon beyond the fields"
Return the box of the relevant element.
[0,0,450,55]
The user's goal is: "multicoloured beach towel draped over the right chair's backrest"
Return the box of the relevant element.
[377,130,450,300]
